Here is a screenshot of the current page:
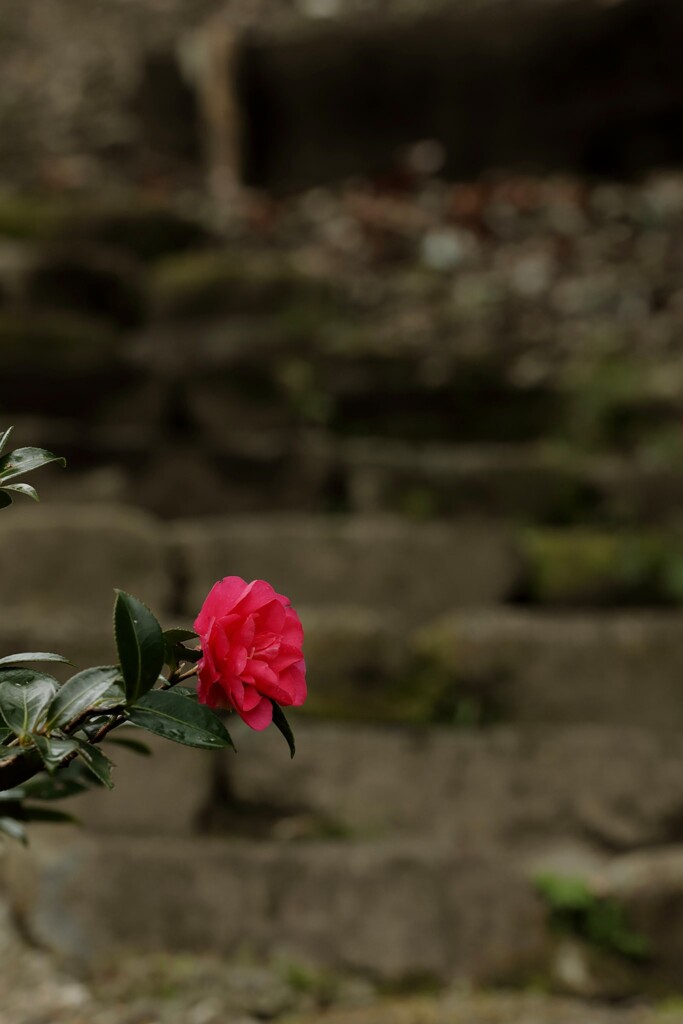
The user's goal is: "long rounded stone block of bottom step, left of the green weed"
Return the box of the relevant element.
[4,834,546,981]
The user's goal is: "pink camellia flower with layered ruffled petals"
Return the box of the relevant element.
[195,577,306,729]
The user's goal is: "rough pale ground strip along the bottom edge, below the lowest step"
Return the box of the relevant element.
[0,934,667,1024]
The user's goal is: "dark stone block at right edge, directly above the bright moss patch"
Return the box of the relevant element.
[339,438,683,524]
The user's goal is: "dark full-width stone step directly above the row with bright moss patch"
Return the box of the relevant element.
[12,413,683,527]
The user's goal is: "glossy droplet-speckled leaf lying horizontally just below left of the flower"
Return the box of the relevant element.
[129,690,234,750]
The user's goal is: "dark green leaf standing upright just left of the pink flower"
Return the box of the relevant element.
[114,590,165,703]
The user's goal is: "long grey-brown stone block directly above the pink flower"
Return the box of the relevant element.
[175,516,515,620]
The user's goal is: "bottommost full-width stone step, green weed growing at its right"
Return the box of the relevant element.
[7,827,683,998]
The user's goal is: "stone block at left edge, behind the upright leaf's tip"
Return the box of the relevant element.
[0,501,170,624]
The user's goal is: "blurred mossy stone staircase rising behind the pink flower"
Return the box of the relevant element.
[0,177,683,997]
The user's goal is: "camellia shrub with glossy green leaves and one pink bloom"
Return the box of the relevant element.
[0,427,306,842]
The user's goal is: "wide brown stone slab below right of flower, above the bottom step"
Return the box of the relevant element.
[213,719,683,851]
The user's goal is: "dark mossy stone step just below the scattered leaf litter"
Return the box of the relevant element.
[136,313,681,452]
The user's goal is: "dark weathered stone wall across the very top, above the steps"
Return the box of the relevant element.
[0,0,683,191]
